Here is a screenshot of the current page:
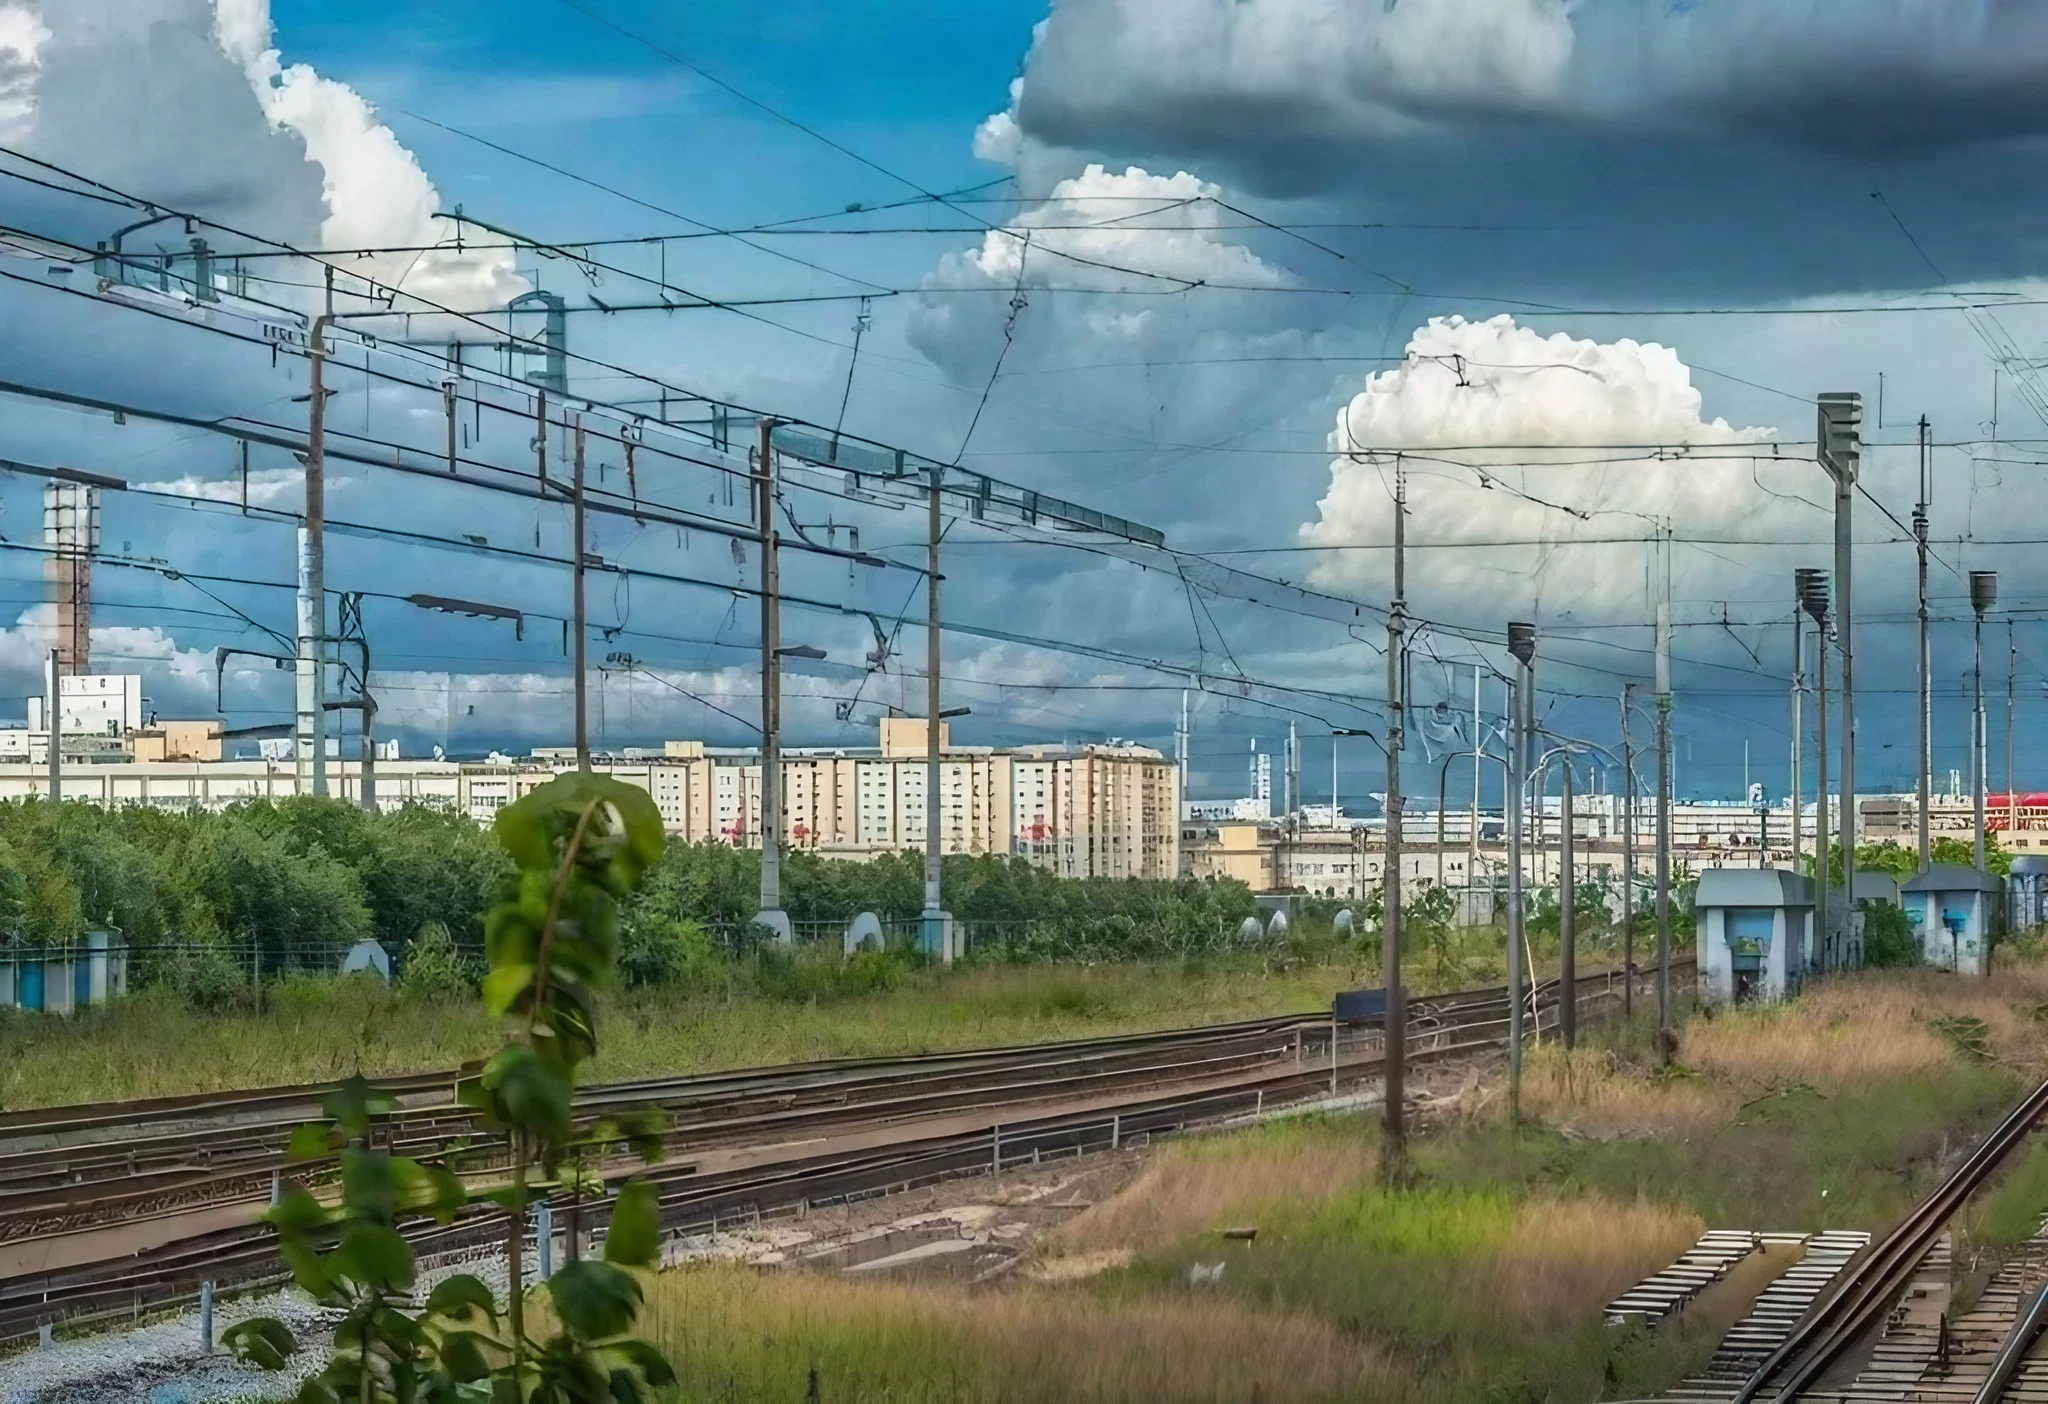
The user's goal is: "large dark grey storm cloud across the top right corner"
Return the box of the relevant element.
[1014,0,2048,299]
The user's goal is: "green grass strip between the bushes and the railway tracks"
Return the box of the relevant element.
[0,933,1630,1109]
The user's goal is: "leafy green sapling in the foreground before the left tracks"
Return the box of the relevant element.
[223,772,676,1404]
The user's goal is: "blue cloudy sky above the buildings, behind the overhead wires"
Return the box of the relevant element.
[0,0,2048,810]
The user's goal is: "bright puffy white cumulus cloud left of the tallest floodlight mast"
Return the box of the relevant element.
[1300,317,1785,622]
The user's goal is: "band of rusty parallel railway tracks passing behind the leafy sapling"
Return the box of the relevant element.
[0,972,1642,1347]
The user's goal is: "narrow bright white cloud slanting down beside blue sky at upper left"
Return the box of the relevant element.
[213,0,526,311]
